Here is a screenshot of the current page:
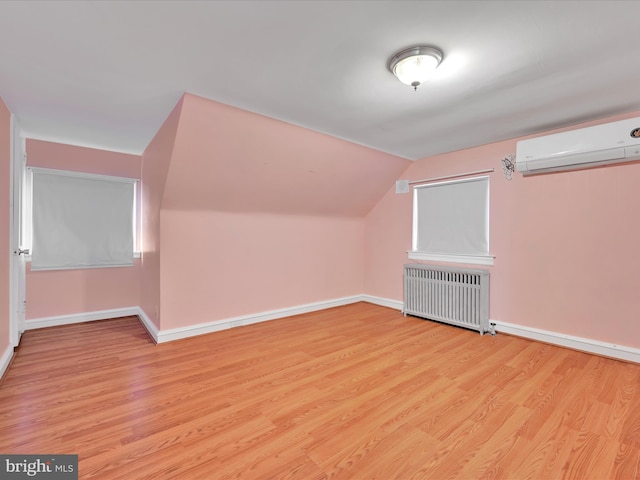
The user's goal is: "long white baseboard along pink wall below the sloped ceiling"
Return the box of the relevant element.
[157,295,362,343]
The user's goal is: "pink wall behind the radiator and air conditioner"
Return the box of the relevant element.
[365,112,640,348]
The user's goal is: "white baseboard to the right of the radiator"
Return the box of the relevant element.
[489,320,640,363]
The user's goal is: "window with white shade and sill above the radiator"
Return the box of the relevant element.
[409,177,493,265]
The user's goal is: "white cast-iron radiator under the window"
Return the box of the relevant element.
[402,264,495,335]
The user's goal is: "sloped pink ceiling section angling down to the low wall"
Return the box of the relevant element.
[160,94,411,217]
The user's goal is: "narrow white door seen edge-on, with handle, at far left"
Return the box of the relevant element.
[9,114,26,347]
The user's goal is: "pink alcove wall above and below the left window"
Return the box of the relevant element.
[26,139,141,320]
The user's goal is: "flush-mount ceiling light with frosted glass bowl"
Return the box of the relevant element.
[388,46,442,90]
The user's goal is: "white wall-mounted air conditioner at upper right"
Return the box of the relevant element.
[516,117,640,175]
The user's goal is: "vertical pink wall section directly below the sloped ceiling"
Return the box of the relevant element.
[161,210,364,329]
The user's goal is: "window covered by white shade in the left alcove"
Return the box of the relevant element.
[25,168,136,270]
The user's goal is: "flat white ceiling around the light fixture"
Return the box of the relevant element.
[0,0,640,160]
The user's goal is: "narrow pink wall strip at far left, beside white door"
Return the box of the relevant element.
[0,98,11,356]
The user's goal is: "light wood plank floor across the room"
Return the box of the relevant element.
[0,303,640,480]
